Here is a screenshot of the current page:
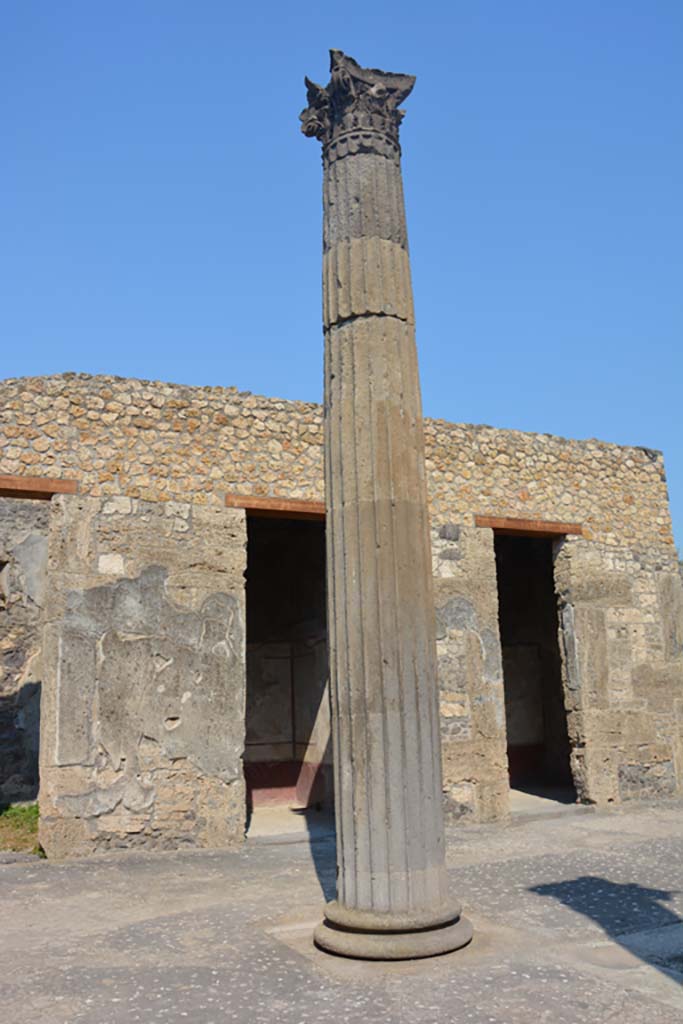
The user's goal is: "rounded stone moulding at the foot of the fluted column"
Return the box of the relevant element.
[313,903,472,961]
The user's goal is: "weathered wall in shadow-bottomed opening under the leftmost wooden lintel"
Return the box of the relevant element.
[0,498,49,805]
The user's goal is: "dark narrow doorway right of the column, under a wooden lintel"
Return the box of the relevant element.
[495,535,575,800]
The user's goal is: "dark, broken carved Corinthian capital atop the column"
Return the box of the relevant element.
[300,50,415,146]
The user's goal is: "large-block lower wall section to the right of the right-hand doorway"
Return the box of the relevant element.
[555,538,683,804]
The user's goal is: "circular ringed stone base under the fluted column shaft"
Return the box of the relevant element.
[313,902,472,961]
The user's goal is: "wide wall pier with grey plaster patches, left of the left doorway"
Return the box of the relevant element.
[40,497,245,857]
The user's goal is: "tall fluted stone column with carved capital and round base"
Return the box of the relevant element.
[301,50,472,959]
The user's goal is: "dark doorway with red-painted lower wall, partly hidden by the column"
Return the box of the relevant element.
[244,516,332,811]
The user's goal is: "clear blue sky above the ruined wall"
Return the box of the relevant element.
[0,0,683,544]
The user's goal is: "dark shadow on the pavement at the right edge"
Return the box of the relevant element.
[528,874,683,984]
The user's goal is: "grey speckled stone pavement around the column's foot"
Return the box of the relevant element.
[0,804,683,1024]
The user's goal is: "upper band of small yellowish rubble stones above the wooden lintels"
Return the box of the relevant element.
[0,374,673,549]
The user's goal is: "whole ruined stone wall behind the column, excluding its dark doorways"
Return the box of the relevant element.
[0,375,683,854]
